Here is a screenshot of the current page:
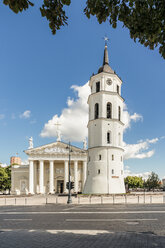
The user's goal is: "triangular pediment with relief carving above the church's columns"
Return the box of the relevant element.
[25,141,86,155]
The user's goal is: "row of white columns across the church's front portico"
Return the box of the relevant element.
[29,160,87,194]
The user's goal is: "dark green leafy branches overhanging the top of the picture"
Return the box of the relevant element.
[3,0,165,58]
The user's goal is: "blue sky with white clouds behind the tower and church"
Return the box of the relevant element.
[0,0,165,178]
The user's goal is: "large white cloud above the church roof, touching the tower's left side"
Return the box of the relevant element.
[40,83,90,142]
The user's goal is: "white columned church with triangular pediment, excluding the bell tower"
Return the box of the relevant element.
[11,141,87,194]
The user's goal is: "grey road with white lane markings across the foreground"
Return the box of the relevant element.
[0,204,165,248]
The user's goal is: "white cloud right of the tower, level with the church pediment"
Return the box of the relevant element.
[123,138,159,159]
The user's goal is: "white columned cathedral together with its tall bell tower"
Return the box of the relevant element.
[11,45,125,194]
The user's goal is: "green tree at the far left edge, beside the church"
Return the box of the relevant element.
[0,166,11,194]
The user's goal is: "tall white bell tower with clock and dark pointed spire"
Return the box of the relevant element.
[83,44,125,194]
